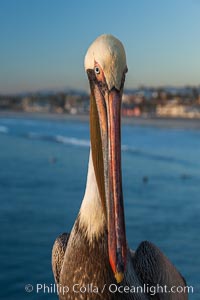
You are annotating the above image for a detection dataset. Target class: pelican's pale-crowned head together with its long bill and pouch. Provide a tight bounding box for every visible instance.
[85,34,127,282]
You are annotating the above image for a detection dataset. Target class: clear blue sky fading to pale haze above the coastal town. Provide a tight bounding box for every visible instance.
[0,0,200,93]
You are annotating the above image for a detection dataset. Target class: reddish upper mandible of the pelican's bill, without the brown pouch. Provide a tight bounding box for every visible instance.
[107,89,126,282]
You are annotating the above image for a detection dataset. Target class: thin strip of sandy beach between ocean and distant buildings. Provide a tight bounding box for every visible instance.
[0,111,200,129]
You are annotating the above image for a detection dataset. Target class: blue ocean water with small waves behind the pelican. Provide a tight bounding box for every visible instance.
[0,118,200,300]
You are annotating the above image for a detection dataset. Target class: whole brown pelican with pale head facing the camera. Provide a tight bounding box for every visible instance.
[52,35,187,300]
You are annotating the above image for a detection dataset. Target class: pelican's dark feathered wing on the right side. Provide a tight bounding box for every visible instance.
[131,241,188,300]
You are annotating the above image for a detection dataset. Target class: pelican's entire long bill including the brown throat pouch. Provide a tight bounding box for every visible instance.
[88,74,126,282]
